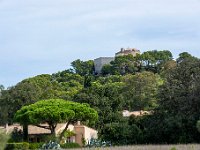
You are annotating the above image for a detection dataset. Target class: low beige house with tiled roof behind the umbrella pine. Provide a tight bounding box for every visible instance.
[0,122,98,146]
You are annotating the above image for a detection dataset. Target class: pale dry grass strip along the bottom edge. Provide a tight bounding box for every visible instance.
[68,144,200,150]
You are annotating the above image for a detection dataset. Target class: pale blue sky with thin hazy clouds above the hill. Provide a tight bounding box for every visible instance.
[0,0,200,87]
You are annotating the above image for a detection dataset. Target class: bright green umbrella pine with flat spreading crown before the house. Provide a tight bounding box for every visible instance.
[15,99,98,141]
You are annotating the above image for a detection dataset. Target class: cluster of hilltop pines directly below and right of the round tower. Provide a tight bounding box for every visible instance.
[102,50,173,75]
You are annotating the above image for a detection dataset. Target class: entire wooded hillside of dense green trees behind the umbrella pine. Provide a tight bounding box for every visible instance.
[0,50,200,145]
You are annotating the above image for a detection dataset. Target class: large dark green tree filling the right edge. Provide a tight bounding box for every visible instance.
[154,58,200,143]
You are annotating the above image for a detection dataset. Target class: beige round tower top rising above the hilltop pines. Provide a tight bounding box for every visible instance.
[115,48,140,57]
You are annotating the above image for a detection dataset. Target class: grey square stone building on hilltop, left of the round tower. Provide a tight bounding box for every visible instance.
[94,57,115,74]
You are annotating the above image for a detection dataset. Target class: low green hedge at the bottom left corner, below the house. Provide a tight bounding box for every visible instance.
[5,142,29,150]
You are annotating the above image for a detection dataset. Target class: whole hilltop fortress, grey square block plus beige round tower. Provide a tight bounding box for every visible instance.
[94,48,140,74]
